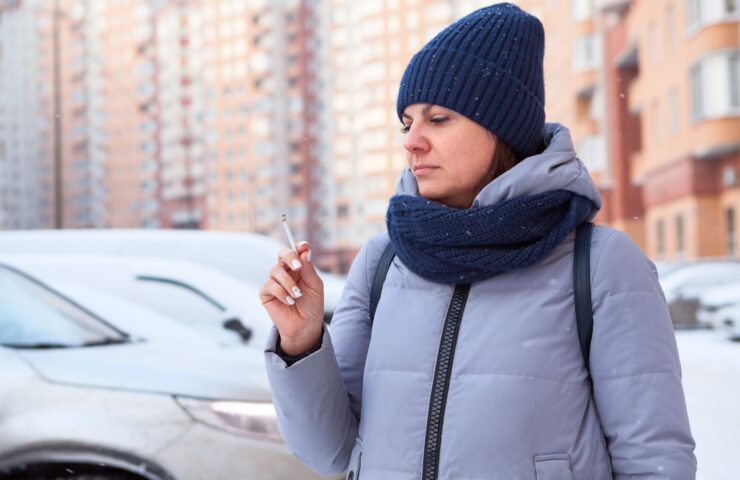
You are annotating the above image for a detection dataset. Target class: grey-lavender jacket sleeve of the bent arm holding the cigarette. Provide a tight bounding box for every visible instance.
[265,235,388,475]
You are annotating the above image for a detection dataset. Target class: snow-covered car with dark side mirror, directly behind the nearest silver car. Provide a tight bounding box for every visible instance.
[0,254,272,349]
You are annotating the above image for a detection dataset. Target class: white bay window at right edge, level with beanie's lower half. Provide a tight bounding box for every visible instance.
[690,50,740,120]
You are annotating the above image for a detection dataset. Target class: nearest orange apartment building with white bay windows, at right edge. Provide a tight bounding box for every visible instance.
[623,0,740,261]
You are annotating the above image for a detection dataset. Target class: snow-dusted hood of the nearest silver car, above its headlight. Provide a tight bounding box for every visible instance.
[18,341,271,402]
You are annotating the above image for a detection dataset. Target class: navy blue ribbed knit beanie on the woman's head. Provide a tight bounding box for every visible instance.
[396,3,545,159]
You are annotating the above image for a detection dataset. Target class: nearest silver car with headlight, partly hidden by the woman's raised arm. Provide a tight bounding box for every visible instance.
[0,263,330,480]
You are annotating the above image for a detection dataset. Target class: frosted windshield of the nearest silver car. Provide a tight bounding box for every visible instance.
[0,266,126,348]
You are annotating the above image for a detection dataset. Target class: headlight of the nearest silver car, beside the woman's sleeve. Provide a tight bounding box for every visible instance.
[175,397,282,442]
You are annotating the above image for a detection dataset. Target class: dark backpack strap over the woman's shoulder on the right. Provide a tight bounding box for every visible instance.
[573,222,594,370]
